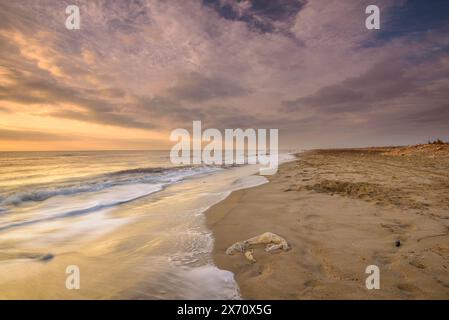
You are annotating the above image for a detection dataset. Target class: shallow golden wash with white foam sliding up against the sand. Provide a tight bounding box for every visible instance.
[0,160,266,300]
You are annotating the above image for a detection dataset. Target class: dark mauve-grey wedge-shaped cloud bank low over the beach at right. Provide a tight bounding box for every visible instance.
[280,59,449,121]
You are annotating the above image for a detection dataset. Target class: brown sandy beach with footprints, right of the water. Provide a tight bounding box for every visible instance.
[206,145,449,299]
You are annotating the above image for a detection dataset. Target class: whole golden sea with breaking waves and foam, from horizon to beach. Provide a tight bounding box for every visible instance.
[0,150,293,299]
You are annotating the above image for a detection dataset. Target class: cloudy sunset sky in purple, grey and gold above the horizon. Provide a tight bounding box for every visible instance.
[0,0,449,151]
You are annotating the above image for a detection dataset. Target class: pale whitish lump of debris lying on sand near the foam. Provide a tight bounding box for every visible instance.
[226,232,290,263]
